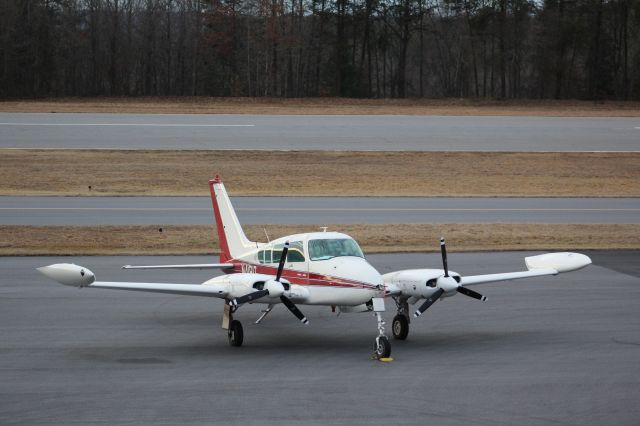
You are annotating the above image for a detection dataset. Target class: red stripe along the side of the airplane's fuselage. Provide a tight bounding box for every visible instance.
[228,259,376,289]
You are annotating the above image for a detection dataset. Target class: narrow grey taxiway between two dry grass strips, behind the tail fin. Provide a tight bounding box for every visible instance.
[0,197,640,225]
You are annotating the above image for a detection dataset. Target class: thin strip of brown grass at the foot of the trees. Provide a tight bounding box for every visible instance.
[0,97,640,117]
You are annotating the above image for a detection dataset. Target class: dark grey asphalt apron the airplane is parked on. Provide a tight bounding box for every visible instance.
[0,252,640,426]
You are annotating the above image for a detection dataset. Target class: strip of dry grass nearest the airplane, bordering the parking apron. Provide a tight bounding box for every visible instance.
[0,224,640,256]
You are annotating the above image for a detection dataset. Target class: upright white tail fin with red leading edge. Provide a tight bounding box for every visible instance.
[209,176,257,263]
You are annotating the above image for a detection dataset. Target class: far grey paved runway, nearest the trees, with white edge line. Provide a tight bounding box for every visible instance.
[0,113,640,151]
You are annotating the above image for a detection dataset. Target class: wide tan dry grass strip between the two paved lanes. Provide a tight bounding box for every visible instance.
[0,149,640,197]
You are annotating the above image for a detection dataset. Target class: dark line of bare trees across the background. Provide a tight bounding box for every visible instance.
[0,0,640,100]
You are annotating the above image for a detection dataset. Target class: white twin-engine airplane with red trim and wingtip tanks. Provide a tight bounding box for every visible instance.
[38,176,591,359]
